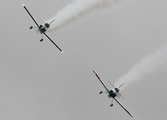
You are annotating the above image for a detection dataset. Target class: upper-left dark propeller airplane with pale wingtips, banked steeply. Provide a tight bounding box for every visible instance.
[23,4,63,53]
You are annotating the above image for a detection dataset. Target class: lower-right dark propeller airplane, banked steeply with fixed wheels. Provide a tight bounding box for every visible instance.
[93,70,133,117]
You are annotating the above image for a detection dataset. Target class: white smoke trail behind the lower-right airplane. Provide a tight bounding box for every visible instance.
[115,44,167,90]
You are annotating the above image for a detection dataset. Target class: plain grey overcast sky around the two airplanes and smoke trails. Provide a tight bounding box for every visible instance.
[0,0,167,120]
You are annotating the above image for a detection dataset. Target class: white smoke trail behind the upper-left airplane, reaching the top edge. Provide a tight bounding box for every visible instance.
[48,0,123,29]
